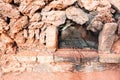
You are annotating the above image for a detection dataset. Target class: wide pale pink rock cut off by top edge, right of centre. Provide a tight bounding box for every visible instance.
[78,0,111,11]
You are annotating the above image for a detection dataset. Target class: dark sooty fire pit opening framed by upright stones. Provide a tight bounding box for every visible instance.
[58,20,98,50]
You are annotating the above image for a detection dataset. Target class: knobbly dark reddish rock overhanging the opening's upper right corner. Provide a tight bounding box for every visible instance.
[87,9,115,32]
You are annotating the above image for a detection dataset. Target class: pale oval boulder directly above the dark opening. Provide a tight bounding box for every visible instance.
[66,6,89,25]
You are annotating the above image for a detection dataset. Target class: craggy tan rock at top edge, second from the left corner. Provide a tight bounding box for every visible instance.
[19,0,45,17]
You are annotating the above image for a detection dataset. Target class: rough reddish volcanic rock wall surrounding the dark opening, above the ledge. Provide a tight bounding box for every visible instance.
[0,0,120,54]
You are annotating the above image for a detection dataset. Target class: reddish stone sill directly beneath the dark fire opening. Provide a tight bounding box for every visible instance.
[55,49,98,58]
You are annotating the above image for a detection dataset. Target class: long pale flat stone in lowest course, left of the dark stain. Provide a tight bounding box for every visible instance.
[33,63,73,72]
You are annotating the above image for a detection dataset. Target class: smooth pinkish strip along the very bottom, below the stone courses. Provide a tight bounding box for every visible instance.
[0,69,120,80]
